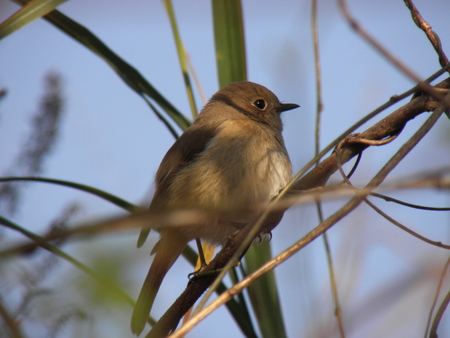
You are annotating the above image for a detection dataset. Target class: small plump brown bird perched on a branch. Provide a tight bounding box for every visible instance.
[131,81,299,335]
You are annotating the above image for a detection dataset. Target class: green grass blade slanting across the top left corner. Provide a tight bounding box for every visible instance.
[0,0,67,39]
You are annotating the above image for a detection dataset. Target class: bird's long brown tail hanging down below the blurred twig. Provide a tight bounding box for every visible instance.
[131,230,188,335]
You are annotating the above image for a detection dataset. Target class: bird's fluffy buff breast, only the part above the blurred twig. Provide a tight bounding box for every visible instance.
[167,120,292,209]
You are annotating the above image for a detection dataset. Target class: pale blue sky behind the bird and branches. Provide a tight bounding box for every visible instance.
[0,0,450,337]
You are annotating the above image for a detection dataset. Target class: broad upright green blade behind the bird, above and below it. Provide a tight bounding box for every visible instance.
[212,0,286,338]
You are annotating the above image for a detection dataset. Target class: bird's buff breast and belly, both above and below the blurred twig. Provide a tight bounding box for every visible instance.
[160,120,292,243]
